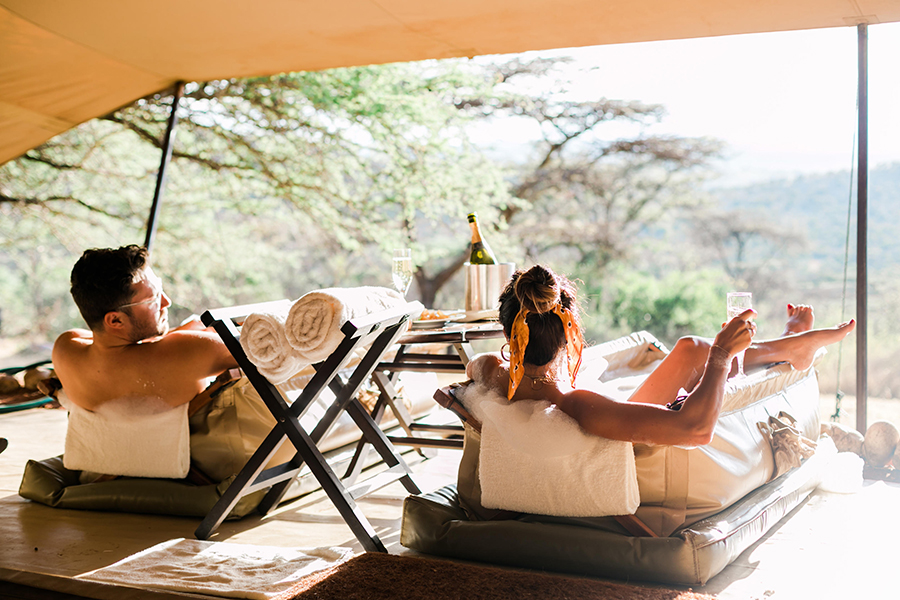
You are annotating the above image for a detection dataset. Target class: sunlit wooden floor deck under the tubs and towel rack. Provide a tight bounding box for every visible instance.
[0,409,900,600]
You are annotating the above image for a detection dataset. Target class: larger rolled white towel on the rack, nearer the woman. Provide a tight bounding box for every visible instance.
[284,287,406,363]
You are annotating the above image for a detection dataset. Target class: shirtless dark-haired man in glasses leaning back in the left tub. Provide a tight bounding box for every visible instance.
[53,245,237,410]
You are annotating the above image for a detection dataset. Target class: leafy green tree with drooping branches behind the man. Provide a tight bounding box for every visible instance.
[0,63,507,330]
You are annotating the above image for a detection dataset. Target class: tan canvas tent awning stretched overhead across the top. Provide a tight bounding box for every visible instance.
[0,0,900,164]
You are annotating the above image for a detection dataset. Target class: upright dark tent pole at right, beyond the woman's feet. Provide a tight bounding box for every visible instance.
[856,23,869,433]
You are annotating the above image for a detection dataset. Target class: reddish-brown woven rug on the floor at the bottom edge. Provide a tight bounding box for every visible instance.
[278,552,714,600]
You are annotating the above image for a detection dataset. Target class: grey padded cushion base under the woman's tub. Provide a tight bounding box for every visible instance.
[400,450,820,585]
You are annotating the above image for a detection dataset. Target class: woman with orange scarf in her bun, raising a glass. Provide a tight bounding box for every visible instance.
[467,265,856,446]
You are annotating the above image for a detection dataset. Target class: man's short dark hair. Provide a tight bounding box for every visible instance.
[71,244,149,330]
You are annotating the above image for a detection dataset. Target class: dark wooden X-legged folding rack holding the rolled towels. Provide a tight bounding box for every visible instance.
[195,300,420,552]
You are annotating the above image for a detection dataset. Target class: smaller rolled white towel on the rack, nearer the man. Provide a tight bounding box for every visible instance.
[241,306,310,384]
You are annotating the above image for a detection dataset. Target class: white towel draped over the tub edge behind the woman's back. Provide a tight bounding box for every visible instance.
[464,385,640,517]
